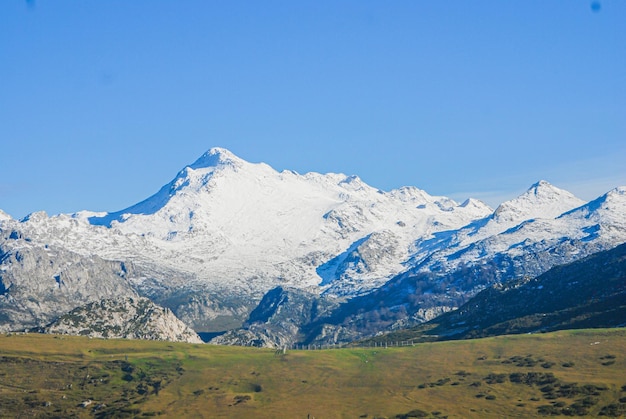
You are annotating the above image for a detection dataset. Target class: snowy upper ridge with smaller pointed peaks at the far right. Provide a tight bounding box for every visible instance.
[412,181,626,275]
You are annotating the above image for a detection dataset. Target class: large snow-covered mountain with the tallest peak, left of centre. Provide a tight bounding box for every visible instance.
[1,149,491,293]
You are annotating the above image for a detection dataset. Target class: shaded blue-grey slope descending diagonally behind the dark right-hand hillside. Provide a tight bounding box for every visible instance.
[214,182,626,344]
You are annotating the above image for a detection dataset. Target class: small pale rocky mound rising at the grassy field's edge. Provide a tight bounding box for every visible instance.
[42,297,202,343]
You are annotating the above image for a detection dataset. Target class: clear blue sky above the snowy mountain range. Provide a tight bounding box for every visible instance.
[0,0,626,218]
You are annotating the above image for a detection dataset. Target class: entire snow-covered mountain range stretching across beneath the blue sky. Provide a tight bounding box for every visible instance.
[0,148,626,344]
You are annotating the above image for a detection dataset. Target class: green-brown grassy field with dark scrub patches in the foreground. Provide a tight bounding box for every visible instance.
[0,329,626,419]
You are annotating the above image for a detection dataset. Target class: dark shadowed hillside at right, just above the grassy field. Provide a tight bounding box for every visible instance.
[360,244,626,340]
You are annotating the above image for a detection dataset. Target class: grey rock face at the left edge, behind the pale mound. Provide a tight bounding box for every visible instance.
[0,231,137,331]
